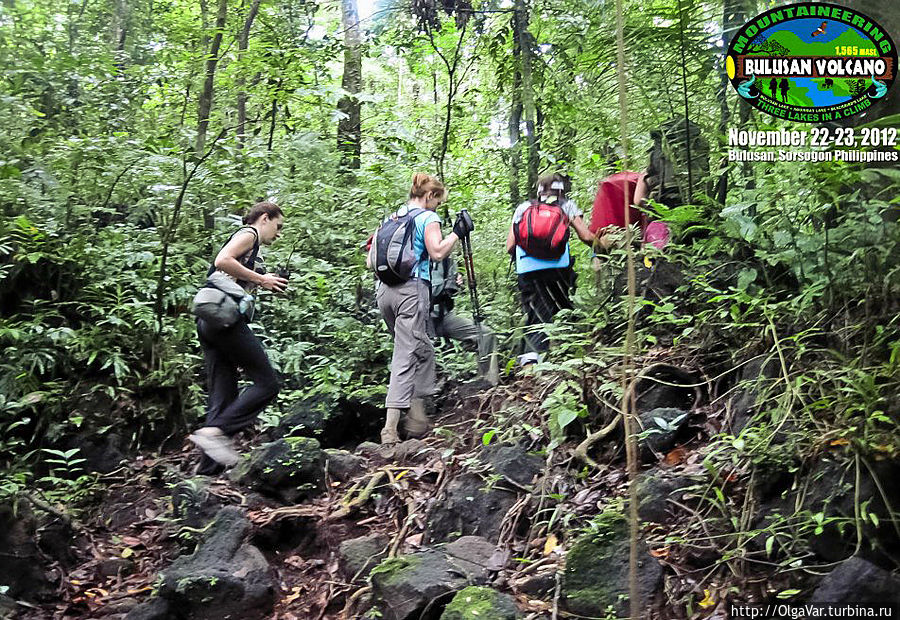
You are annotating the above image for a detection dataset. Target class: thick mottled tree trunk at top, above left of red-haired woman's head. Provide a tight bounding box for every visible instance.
[337,0,362,170]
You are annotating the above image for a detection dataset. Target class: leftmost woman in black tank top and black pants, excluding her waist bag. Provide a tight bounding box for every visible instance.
[190,202,287,475]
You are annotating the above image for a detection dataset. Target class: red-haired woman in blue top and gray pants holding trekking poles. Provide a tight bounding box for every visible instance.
[366,173,473,444]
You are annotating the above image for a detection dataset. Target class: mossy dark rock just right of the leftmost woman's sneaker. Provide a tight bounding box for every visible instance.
[231,437,325,504]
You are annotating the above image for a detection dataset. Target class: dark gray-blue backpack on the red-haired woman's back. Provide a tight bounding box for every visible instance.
[370,208,427,286]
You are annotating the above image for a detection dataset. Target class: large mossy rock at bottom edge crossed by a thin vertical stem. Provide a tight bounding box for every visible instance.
[562,512,662,616]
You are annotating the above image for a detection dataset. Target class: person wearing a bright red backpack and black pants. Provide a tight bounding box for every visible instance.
[506,173,594,366]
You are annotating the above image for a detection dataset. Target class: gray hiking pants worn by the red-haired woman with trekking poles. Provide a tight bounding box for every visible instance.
[375,278,435,409]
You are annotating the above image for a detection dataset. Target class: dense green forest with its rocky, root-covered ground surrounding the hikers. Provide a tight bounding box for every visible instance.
[0,0,900,620]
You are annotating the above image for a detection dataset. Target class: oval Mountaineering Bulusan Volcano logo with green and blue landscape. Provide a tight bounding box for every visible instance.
[725,2,897,123]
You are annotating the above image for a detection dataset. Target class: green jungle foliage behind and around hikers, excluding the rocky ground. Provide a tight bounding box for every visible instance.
[0,0,900,612]
